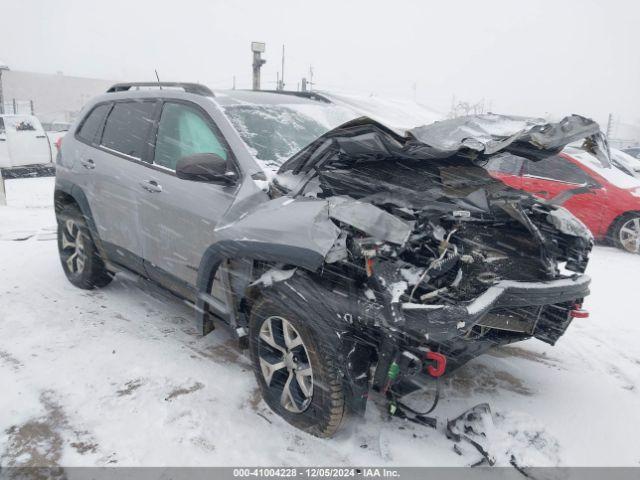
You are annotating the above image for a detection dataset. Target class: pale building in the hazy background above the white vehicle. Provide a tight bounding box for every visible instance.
[0,65,116,123]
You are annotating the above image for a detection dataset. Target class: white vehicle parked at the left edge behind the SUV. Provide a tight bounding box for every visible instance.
[0,115,53,170]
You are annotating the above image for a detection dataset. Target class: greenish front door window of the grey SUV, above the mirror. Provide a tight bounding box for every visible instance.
[153,103,228,170]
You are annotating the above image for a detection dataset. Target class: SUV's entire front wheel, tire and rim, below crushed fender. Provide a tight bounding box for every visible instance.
[249,295,345,437]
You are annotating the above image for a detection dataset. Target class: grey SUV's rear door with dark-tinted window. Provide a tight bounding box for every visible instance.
[81,99,158,272]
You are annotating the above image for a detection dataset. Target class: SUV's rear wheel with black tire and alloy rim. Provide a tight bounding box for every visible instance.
[56,204,113,290]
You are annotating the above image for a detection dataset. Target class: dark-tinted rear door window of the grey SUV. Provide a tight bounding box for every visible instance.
[100,102,156,159]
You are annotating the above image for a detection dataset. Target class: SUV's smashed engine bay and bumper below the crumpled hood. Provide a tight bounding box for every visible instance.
[320,165,593,398]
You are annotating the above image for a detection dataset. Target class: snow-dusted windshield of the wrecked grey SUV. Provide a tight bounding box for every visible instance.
[225,104,359,170]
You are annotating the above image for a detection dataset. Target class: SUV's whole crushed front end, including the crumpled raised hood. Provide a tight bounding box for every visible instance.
[275,116,603,398]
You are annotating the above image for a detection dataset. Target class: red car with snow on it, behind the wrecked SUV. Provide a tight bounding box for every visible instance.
[486,148,640,253]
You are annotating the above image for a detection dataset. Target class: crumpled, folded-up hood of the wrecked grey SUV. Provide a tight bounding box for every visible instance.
[278,113,610,174]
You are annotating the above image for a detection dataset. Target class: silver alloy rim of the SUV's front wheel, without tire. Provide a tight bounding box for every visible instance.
[258,316,313,413]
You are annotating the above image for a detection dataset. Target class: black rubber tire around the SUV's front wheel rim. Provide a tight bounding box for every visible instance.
[249,285,347,437]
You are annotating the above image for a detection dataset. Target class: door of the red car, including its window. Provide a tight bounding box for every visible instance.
[522,155,607,235]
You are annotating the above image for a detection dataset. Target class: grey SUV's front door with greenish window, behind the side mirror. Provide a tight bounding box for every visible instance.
[140,100,238,296]
